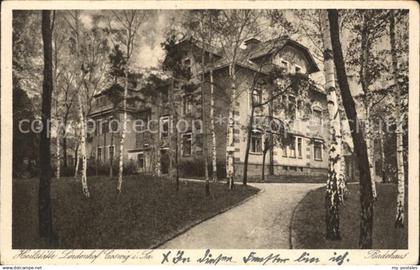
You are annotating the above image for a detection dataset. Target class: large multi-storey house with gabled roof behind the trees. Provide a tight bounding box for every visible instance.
[88,37,329,177]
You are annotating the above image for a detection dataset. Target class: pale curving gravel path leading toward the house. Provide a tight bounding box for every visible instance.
[158,183,322,249]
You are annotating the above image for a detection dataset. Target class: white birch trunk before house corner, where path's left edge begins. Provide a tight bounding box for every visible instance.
[226,63,236,190]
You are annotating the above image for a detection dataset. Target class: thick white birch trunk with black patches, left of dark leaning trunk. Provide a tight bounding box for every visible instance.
[322,12,344,240]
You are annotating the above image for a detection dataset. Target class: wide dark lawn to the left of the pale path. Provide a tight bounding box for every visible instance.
[12,176,258,249]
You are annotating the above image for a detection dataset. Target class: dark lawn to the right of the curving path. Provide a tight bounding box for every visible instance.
[292,184,408,249]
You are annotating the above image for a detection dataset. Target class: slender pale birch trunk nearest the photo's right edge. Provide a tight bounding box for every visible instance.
[389,11,405,228]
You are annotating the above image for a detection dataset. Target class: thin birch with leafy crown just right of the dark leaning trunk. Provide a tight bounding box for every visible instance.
[343,10,388,199]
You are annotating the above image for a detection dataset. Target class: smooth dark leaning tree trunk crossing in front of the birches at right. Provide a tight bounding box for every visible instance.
[328,9,373,249]
